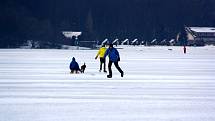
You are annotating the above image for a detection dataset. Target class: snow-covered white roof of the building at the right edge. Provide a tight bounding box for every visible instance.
[189,27,215,33]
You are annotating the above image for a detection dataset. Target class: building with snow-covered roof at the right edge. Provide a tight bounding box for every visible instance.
[185,27,215,46]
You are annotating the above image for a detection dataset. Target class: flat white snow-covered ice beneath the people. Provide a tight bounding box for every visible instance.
[0,46,215,121]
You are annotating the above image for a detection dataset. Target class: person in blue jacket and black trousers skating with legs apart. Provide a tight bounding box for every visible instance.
[104,44,124,78]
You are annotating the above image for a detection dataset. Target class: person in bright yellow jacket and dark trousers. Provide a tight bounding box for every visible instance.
[95,45,107,73]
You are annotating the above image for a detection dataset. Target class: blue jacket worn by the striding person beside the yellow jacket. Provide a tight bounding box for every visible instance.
[104,48,120,62]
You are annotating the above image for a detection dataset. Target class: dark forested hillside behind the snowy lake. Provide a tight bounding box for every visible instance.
[0,0,215,48]
